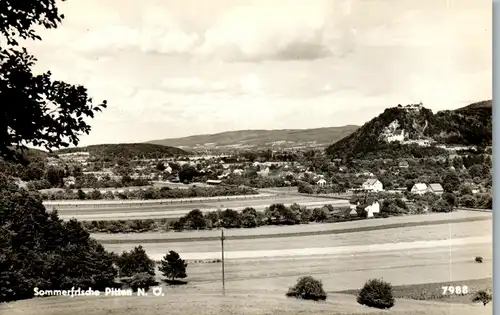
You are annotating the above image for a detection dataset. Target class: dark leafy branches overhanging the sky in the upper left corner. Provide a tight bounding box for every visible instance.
[0,0,106,159]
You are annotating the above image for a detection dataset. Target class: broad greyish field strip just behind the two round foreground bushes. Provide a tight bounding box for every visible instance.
[184,244,492,292]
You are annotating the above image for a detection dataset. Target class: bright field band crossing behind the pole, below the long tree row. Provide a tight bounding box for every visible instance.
[104,220,492,259]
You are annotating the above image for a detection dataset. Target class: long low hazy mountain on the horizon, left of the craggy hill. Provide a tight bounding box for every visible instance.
[147,125,359,150]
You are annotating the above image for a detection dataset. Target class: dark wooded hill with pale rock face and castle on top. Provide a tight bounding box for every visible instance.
[326,100,493,159]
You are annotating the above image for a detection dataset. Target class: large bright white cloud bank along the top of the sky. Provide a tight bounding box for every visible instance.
[34,0,344,61]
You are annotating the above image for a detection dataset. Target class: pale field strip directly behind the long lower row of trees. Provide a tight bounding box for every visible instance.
[55,197,349,221]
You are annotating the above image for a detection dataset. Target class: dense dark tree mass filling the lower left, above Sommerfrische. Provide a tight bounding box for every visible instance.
[0,176,116,302]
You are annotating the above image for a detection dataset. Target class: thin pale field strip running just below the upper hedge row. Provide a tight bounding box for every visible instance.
[43,193,276,208]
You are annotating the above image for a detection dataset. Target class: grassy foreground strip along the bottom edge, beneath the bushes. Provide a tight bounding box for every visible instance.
[0,289,492,315]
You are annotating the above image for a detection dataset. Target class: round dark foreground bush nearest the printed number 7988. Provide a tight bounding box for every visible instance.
[357,279,394,309]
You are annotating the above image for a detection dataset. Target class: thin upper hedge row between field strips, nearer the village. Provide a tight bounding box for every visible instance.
[42,186,258,200]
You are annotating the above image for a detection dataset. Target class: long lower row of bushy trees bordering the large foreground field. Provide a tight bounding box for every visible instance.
[83,195,440,233]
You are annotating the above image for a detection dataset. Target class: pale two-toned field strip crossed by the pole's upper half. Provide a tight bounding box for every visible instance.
[103,221,492,260]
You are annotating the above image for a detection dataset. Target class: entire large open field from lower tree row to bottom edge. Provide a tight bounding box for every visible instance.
[0,214,492,315]
